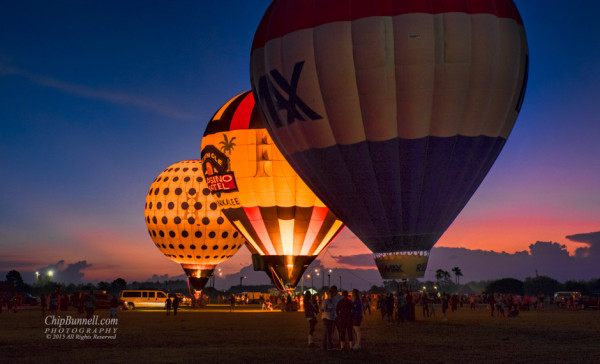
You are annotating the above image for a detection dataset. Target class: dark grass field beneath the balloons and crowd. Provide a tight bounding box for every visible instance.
[0,306,600,364]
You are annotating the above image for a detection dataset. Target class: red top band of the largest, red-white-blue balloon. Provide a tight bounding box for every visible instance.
[252,0,523,50]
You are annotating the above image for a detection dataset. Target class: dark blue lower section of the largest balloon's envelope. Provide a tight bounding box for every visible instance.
[288,135,506,253]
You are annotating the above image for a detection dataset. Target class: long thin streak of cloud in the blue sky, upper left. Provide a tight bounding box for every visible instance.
[0,62,198,121]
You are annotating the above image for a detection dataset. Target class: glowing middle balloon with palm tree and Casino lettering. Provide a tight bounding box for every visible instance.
[201,91,343,290]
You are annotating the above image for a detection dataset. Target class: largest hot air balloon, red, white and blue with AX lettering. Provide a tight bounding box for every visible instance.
[250,0,528,279]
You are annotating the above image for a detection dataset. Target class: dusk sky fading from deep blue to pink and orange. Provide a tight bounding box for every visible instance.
[0,0,600,288]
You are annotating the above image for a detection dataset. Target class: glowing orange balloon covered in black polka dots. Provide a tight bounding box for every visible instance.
[145,160,244,291]
